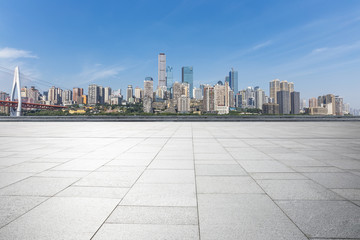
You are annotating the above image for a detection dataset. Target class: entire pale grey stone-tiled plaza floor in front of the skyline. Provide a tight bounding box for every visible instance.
[0,122,360,240]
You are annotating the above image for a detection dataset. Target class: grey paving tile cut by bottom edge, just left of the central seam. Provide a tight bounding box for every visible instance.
[93,224,199,240]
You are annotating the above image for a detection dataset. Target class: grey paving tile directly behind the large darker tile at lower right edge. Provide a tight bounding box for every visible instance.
[257,180,343,200]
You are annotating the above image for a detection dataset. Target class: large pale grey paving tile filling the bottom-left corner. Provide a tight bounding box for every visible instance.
[0,197,118,240]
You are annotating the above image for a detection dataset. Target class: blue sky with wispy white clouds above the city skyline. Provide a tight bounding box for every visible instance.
[0,0,360,108]
